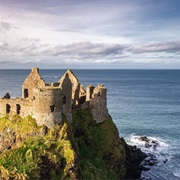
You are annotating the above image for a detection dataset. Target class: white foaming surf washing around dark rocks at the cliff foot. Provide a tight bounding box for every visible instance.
[126,134,180,180]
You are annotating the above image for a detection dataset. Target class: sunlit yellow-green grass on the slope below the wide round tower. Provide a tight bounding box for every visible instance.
[0,117,76,179]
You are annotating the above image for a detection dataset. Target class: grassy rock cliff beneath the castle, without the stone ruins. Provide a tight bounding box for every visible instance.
[0,109,144,180]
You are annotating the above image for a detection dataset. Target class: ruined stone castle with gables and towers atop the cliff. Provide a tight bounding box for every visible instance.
[0,68,109,127]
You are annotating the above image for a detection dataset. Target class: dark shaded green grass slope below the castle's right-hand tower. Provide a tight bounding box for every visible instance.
[72,110,126,179]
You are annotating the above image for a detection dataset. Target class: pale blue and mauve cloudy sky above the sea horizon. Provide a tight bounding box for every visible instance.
[0,0,180,69]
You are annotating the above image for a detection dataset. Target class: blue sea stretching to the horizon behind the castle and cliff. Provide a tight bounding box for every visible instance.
[0,69,180,180]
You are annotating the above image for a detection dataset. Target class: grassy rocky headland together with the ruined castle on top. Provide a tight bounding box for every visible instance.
[0,68,146,180]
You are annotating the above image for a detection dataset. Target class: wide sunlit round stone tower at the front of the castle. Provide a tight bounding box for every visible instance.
[33,87,63,127]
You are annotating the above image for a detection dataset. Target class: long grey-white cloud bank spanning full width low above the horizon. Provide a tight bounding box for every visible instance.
[0,38,180,67]
